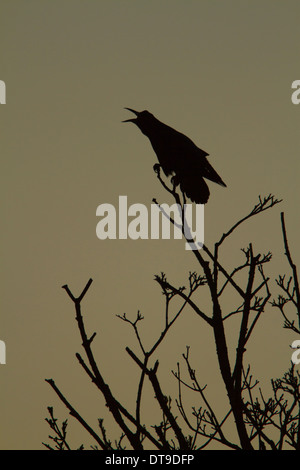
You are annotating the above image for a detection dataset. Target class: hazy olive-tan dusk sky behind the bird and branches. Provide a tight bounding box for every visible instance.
[0,0,300,449]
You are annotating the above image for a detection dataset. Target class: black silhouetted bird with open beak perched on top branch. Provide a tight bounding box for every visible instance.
[123,108,226,204]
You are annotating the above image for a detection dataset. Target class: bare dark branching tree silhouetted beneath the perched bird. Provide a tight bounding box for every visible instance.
[45,171,300,450]
